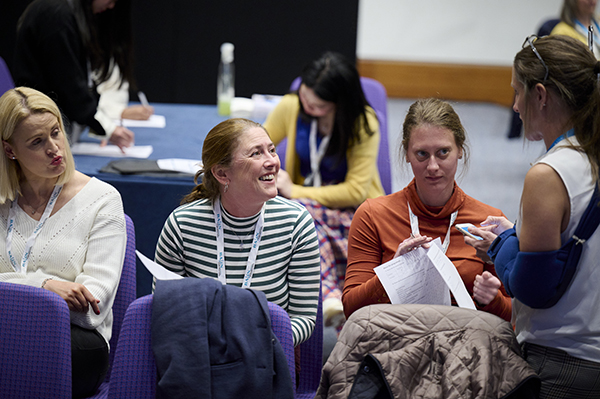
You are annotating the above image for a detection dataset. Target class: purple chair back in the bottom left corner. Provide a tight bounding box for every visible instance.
[0,283,71,399]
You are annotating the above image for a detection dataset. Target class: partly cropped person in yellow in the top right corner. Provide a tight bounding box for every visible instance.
[550,0,600,58]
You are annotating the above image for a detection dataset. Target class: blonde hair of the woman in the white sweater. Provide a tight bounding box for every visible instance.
[0,87,75,204]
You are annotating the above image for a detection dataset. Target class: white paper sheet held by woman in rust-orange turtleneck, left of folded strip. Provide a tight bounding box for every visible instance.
[375,239,450,306]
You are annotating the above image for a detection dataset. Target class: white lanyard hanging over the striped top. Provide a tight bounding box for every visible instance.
[213,198,265,288]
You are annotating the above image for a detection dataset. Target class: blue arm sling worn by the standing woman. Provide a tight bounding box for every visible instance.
[488,186,600,309]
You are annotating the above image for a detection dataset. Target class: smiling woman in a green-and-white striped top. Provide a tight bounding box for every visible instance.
[155,119,320,346]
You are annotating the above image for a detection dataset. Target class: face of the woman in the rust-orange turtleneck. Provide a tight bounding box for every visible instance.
[406,123,463,206]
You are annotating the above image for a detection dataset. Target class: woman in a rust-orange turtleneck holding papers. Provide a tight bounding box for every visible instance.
[342,99,511,321]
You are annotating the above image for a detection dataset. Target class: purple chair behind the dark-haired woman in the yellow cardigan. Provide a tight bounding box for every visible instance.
[277,77,392,194]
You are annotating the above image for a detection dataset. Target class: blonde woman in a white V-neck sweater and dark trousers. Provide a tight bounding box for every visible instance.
[0,87,127,398]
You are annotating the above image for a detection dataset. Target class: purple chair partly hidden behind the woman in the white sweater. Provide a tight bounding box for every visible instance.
[92,215,136,398]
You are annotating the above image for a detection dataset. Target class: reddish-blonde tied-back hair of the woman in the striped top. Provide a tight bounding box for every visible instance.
[181,118,268,204]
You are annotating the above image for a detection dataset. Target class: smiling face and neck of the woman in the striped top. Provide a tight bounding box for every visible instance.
[213,127,280,217]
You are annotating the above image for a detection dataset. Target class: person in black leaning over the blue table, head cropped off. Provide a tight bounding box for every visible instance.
[13,0,153,148]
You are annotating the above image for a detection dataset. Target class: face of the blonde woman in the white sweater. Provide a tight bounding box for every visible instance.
[3,112,66,179]
